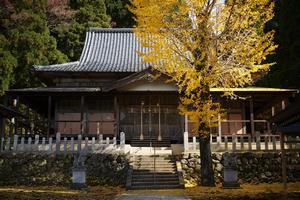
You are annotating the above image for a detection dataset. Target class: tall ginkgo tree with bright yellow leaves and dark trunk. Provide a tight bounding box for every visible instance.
[129,0,276,186]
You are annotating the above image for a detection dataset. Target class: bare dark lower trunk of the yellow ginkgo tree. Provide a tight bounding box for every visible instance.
[199,135,215,187]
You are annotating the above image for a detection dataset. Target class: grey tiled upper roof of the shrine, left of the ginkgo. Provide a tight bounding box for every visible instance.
[34,28,149,72]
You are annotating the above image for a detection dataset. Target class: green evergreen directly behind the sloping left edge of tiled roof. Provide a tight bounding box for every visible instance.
[52,0,110,61]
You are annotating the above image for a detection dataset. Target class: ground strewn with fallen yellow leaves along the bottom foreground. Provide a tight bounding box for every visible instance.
[0,182,300,200]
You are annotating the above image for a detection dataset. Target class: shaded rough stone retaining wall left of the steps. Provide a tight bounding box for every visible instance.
[0,154,129,186]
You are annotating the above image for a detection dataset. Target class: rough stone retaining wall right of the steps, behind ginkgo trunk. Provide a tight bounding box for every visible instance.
[181,152,300,186]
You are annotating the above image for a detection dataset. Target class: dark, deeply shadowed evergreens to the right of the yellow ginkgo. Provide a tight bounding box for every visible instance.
[257,0,300,88]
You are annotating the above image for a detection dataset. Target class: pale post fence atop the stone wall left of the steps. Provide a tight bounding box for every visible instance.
[0,132,125,154]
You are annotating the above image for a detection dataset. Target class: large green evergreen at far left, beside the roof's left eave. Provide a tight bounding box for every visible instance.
[0,0,67,91]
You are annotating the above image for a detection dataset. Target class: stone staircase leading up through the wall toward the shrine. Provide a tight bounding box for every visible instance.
[126,155,184,189]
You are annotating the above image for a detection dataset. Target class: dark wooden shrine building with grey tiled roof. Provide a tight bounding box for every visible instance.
[7,28,297,146]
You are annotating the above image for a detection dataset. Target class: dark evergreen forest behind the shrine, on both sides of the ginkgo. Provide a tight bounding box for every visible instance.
[0,0,300,95]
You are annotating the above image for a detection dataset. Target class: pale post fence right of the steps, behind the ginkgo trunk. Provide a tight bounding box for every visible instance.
[184,132,299,152]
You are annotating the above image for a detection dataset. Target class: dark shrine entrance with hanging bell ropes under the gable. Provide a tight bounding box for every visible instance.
[120,95,183,147]
